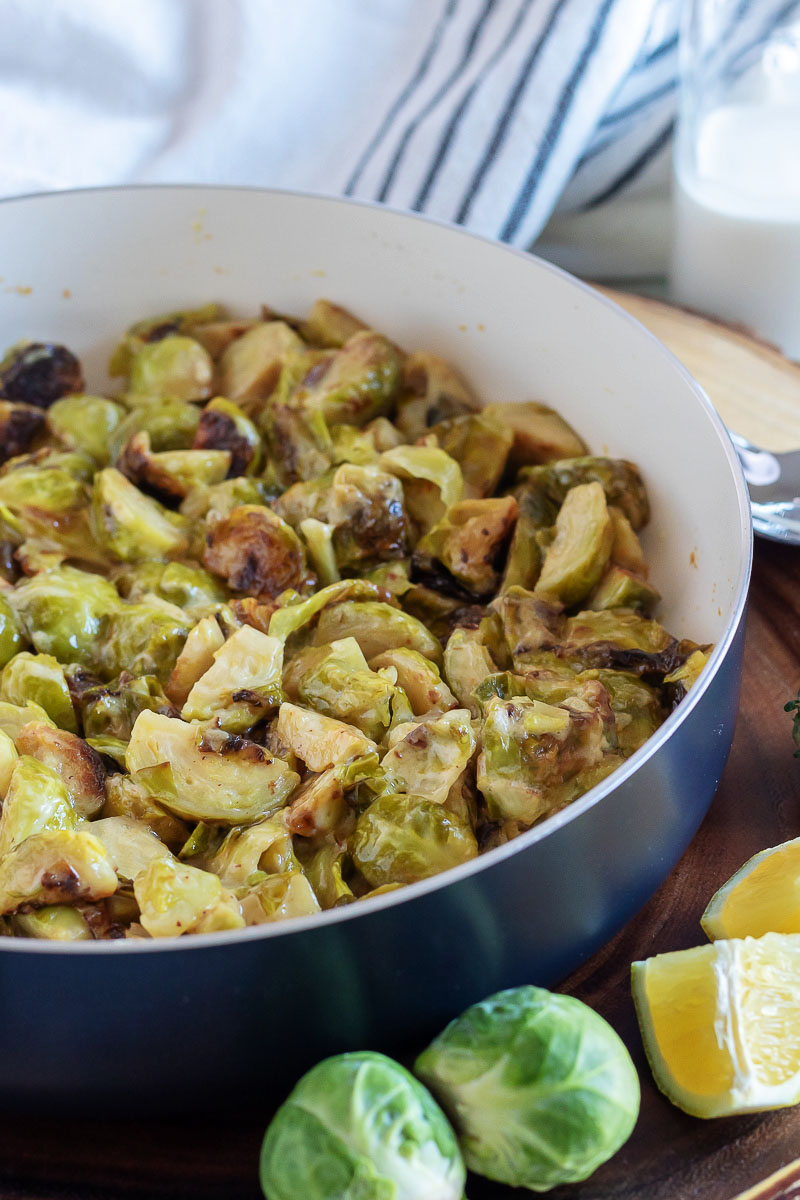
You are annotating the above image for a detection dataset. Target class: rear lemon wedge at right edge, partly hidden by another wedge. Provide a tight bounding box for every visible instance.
[700,838,800,941]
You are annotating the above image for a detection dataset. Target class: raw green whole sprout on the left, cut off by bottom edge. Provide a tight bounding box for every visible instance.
[260,1050,467,1200]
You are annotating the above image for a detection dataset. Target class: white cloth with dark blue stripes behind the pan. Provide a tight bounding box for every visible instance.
[0,0,795,270]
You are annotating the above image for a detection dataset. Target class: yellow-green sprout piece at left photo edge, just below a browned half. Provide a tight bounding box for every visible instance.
[0,754,78,858]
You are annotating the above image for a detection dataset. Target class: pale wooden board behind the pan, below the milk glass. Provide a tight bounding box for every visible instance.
[597,287,800,450]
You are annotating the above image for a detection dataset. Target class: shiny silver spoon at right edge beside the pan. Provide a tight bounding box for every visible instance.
[730,433,800,545]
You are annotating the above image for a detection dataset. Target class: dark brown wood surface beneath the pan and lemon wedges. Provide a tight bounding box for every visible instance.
[0,541,800,1200]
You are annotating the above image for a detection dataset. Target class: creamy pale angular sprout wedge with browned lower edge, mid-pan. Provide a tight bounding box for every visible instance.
[181,625,283,733]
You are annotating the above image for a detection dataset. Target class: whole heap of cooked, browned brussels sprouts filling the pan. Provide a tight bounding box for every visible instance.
[0,300,710,942]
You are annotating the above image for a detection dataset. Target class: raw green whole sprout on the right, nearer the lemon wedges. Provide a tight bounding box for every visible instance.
[414,986,639,1192]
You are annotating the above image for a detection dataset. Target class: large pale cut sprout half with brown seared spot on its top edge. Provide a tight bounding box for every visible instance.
[126,710,300,824]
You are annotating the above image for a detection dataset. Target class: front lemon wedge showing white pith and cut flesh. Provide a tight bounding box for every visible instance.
[632,934,800,1117]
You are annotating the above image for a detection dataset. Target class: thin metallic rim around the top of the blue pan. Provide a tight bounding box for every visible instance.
[0,182,753,956]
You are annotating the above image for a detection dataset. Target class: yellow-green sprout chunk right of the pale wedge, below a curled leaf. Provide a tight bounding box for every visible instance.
[293,637,411,742]
